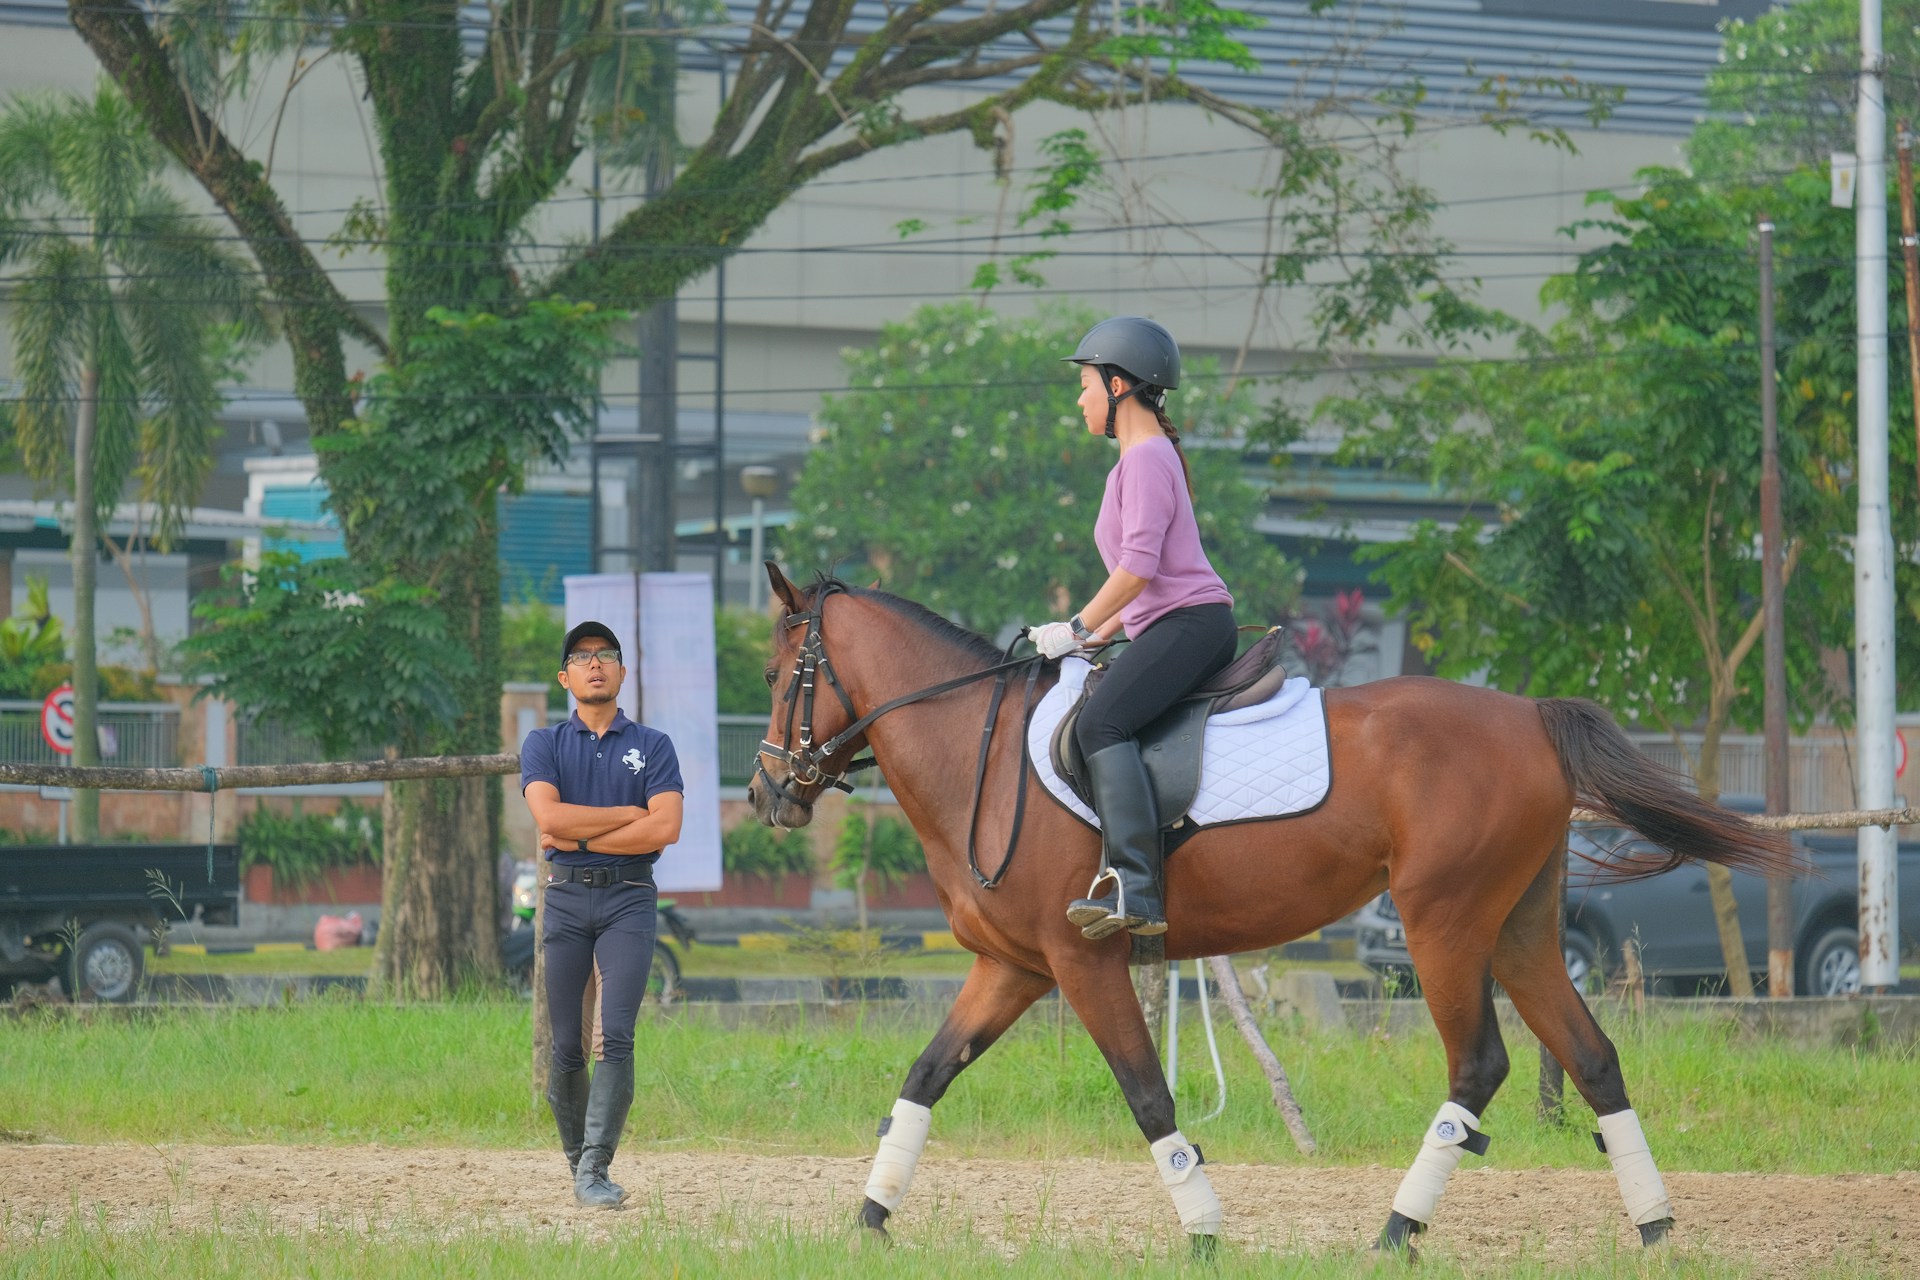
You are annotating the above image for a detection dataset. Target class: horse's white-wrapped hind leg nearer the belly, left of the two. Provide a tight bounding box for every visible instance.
[1375,924,1507,1251]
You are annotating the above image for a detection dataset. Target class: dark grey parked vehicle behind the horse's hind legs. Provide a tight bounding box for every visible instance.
[1354,798,1920,996]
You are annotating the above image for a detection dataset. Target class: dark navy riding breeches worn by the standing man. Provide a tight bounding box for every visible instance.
[540,882,659,1071]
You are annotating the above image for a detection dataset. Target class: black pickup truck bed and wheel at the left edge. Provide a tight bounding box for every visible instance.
[0,844,240,1002]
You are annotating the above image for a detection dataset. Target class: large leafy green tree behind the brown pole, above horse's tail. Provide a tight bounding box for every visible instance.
[1336,169,1920,990]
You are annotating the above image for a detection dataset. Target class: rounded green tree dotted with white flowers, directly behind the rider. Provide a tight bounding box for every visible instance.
[787,303,1300,637]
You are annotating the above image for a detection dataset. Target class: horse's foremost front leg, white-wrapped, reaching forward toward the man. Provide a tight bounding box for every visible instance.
[860,956,1054,1238]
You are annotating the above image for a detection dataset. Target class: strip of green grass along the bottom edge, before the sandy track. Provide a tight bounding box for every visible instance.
[0,1209,1880,1280]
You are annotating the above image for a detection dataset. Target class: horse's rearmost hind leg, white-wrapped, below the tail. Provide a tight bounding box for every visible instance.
[1494,858,1674,1245]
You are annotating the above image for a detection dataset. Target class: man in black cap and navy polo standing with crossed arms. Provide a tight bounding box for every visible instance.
[520,622,684,1209]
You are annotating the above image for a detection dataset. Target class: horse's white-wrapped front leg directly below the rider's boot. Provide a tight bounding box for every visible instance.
[1050,951,1221,1257]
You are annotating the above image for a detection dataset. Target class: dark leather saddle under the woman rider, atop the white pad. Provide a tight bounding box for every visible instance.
[1050,628,1286,832]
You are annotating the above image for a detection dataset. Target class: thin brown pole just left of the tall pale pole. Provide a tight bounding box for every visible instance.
[1761,213,1793,1000]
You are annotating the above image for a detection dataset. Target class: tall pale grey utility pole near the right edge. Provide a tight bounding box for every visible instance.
[1853,0,1901,990]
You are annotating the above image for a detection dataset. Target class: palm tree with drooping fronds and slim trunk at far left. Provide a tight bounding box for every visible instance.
[0,81,265,839]
